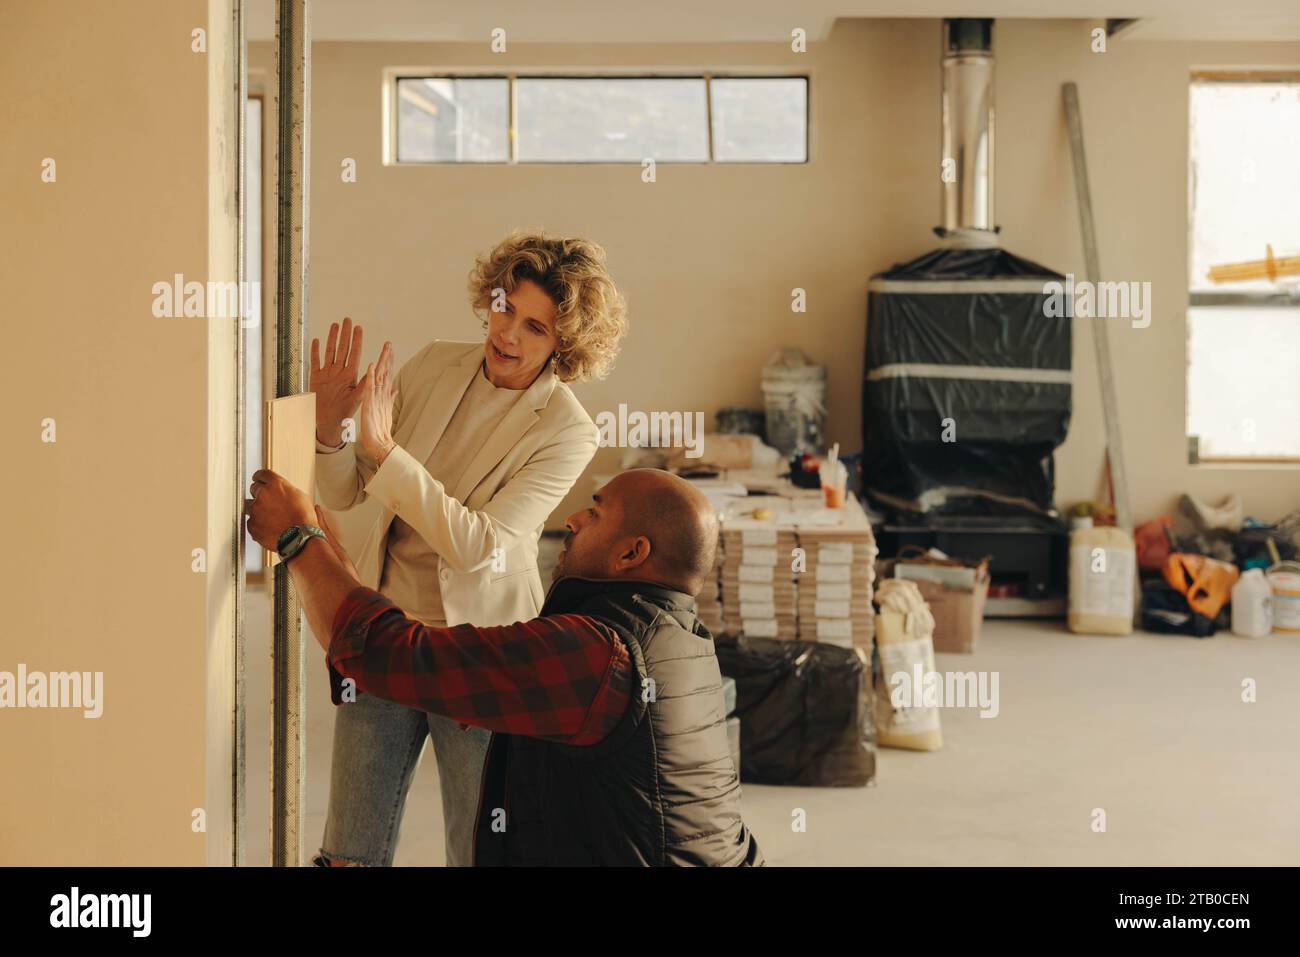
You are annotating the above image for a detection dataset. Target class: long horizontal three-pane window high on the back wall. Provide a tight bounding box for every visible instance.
[387,74,809,164]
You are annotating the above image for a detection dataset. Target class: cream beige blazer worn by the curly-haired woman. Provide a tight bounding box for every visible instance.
[316,339,599,625]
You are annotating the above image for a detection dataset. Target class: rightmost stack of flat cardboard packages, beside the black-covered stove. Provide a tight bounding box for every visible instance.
[796,497,876,649]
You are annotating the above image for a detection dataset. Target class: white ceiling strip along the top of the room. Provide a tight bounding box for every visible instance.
[247,0,1300,43]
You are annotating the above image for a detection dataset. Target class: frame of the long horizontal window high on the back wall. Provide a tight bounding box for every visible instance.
[384,66,813,166]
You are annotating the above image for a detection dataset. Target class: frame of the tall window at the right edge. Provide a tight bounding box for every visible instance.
[1183,69,1300,467]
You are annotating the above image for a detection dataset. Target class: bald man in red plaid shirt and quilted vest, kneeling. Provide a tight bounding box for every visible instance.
[246,468,763,866]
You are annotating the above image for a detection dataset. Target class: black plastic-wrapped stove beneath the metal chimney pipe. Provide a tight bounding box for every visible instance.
[862,248,1073,515]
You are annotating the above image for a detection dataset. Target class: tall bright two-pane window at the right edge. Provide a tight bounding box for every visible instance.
[1187,74,1300,462]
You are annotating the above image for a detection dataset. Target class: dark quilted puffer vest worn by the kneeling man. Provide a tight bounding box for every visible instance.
[475,577,763,867]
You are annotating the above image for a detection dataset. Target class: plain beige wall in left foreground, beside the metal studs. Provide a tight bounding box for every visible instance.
[0,0,234,865]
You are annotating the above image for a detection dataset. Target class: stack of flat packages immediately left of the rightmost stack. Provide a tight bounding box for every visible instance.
[722,518,798,641]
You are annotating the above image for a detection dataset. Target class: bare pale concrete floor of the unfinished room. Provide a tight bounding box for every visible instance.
[247,592,1300,866]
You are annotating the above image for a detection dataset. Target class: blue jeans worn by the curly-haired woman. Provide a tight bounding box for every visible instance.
[321,694,491,867]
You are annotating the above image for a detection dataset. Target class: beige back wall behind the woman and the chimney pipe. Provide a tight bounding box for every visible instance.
[254,20,1300,546]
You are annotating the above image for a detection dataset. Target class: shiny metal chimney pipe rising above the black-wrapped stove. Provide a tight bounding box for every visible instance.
[936,18,997,246]
